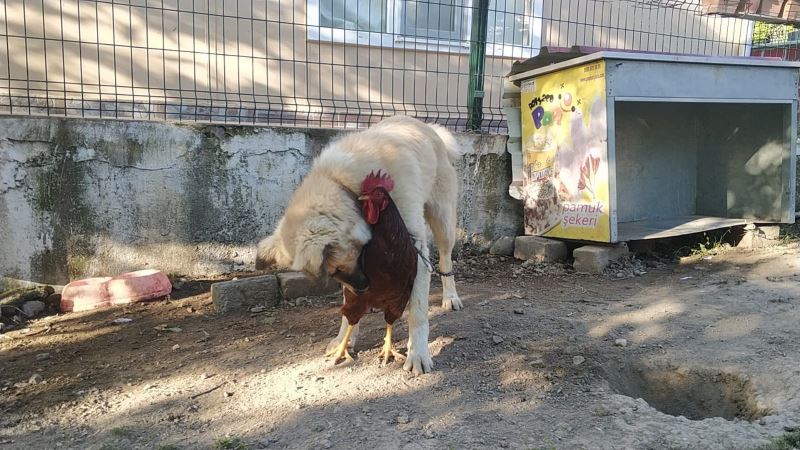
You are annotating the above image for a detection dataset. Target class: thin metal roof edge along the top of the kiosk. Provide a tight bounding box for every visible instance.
[508,51,800,81]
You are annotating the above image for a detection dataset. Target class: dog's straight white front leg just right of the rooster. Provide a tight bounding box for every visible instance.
[403,251,433,375]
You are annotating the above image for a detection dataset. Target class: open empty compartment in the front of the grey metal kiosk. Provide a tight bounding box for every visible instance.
[614,101,791,241]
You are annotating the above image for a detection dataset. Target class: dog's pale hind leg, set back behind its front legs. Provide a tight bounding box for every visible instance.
[425,199,463,311]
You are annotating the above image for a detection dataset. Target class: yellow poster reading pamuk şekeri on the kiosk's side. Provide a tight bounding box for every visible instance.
[521,61,611,242]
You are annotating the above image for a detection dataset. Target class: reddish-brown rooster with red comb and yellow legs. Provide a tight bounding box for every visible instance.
[326,170,417,366]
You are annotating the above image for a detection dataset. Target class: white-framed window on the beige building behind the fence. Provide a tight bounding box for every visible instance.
[308,0,542,58]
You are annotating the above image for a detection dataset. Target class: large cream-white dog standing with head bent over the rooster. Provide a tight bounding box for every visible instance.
[256,116,462,375]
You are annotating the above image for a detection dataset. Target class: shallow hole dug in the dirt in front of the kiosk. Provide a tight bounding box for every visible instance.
[605,365,771,421]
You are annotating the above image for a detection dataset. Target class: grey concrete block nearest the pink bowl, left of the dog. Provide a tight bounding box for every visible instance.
[211,275,281,313]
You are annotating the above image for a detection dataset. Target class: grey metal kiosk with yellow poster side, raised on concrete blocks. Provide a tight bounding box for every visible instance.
[504,51,800,243]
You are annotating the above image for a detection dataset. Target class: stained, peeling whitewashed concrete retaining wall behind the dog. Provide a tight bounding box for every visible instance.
[0,117,522,283]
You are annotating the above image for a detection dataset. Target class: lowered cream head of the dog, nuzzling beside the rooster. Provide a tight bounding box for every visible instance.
[256,179,371,293]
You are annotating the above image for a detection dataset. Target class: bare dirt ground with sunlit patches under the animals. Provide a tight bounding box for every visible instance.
[0,245,800,449]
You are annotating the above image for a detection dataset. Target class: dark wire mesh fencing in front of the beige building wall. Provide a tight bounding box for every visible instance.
[0,0,754,131]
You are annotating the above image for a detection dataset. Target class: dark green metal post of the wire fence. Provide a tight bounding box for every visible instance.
[467,0,489,130]
